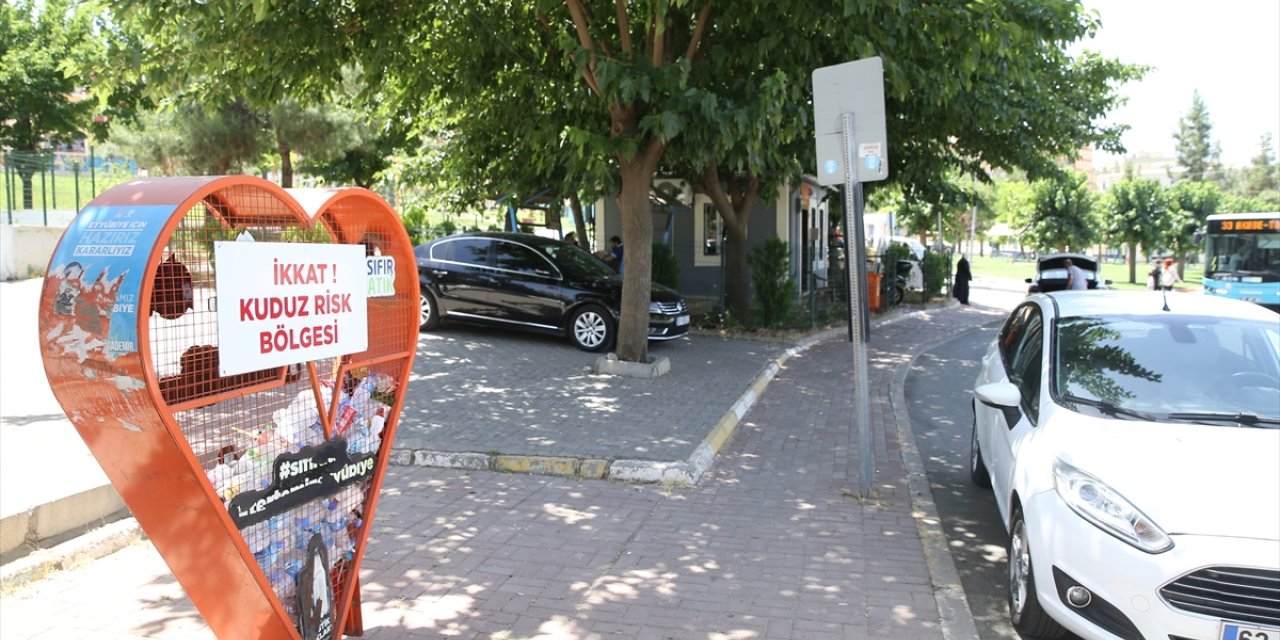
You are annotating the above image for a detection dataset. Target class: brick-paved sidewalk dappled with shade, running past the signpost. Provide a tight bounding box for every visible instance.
[0,302,1002,639]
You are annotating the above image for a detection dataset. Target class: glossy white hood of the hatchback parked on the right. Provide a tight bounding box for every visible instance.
[1043,417,1280,540]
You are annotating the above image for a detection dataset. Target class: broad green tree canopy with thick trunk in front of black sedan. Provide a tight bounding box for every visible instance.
[97,0,1142,360]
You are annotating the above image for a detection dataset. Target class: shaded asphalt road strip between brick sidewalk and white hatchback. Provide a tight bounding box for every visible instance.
[904,323,1090,640]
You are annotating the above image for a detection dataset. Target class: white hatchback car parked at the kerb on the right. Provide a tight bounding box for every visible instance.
[969,291,1280,640]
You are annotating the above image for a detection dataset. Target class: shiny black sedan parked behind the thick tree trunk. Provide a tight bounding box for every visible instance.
[413,233,689,351]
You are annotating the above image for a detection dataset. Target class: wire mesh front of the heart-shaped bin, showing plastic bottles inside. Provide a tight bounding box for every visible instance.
[148,187,416,620]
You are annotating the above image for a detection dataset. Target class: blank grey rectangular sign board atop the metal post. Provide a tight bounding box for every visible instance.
[813,58,888,186]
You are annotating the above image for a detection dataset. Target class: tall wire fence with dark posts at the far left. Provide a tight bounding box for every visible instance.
[0,147,138,227]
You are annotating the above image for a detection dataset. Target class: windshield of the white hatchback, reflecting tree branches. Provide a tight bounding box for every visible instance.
[1051,314,1280,426]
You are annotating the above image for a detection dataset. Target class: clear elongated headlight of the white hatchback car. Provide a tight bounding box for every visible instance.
[1053,460,1174,553]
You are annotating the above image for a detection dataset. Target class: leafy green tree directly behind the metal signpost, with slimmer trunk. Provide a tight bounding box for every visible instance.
[666,1,1143,320]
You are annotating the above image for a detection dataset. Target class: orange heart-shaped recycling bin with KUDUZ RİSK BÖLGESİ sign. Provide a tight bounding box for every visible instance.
[40,177,419,639]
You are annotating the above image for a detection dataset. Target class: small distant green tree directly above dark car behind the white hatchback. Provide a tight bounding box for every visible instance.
[1023,172,1098,251]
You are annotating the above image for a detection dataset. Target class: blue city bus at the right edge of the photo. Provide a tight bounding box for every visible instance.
[1204,212,1280,314]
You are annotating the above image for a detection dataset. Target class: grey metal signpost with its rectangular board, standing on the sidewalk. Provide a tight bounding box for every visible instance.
[813,58,888,498]
